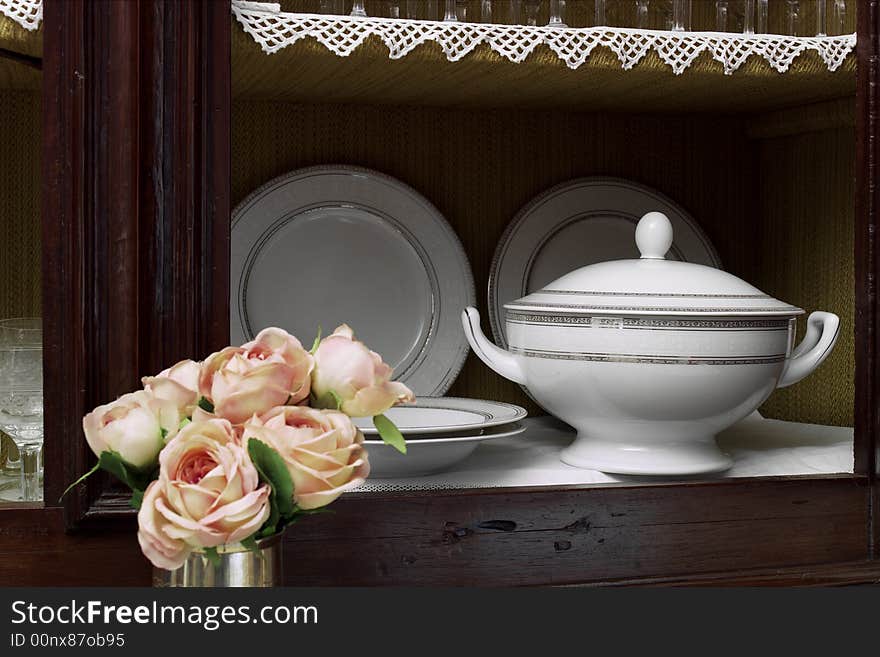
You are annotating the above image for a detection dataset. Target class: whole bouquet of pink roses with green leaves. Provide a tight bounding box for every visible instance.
[68,325,414,570]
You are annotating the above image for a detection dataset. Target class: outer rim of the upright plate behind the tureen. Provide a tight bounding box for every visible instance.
[486,176,723,348]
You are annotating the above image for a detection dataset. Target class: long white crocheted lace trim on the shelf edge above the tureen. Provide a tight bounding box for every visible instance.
[232,0,856,75]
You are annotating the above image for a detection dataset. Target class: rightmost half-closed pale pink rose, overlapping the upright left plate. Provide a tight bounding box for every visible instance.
[312,324,415,417]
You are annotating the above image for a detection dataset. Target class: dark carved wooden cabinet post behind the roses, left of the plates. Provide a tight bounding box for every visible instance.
[43,0,230,526]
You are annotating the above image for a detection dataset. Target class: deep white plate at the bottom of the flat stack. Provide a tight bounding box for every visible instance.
[364,422,526,478]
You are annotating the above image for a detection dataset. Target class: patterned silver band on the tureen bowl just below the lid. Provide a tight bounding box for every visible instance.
[507,311,789,331]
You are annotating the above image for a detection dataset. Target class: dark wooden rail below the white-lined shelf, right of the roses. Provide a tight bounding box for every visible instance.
[285,478,870,586]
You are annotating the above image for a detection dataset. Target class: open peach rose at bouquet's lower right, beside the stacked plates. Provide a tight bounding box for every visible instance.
[243,406,370,509]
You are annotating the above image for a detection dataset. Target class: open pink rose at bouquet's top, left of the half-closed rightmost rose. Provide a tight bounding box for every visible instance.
[199,328,314,424]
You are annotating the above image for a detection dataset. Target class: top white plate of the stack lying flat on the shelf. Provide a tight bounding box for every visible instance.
[354,397,528,439]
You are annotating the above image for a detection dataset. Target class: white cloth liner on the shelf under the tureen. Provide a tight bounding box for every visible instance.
[356,413,853,492]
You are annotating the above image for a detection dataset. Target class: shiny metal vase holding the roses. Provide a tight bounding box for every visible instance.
[153,534,284,587]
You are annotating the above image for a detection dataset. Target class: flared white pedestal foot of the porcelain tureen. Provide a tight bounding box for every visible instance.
[560,432,733,475]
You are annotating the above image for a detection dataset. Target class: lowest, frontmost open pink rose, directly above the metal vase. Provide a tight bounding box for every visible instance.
[138,419,270,570]
